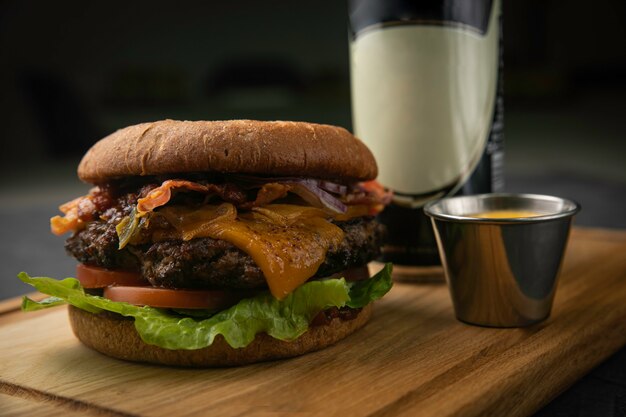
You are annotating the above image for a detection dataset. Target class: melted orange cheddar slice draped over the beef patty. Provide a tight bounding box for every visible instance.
[159,203,343,299]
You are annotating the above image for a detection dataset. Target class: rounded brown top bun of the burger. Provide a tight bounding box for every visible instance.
[78,120,377,183]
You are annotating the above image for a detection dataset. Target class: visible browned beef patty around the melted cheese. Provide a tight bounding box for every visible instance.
[65,218,384,289]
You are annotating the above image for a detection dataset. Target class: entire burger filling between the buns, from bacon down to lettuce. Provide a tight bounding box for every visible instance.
[19,175,391,349]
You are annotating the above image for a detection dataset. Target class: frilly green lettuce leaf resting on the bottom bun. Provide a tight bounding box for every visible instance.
[18,265,392,349]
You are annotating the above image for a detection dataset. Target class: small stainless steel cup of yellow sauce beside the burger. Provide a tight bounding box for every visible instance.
[424,194,580,327]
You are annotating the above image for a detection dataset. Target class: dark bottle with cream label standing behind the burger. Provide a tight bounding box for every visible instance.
[348,0,503,266]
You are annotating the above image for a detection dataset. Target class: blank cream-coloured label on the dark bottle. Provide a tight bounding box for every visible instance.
[351,2,499,206]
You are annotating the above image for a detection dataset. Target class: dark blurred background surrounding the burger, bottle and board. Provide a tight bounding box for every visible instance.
[0,0,626,416]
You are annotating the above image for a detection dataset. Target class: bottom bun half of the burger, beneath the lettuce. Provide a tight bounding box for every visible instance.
[69,304,372,367]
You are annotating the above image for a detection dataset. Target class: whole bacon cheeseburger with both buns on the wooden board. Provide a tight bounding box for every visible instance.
[19,120,391,367]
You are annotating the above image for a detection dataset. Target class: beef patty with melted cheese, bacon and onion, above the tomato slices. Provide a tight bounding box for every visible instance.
[52,177,387,298]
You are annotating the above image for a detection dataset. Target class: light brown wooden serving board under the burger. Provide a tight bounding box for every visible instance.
[0,229,626,417]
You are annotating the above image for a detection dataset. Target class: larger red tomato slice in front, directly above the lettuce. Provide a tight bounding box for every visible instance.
[104,286,250,309]
